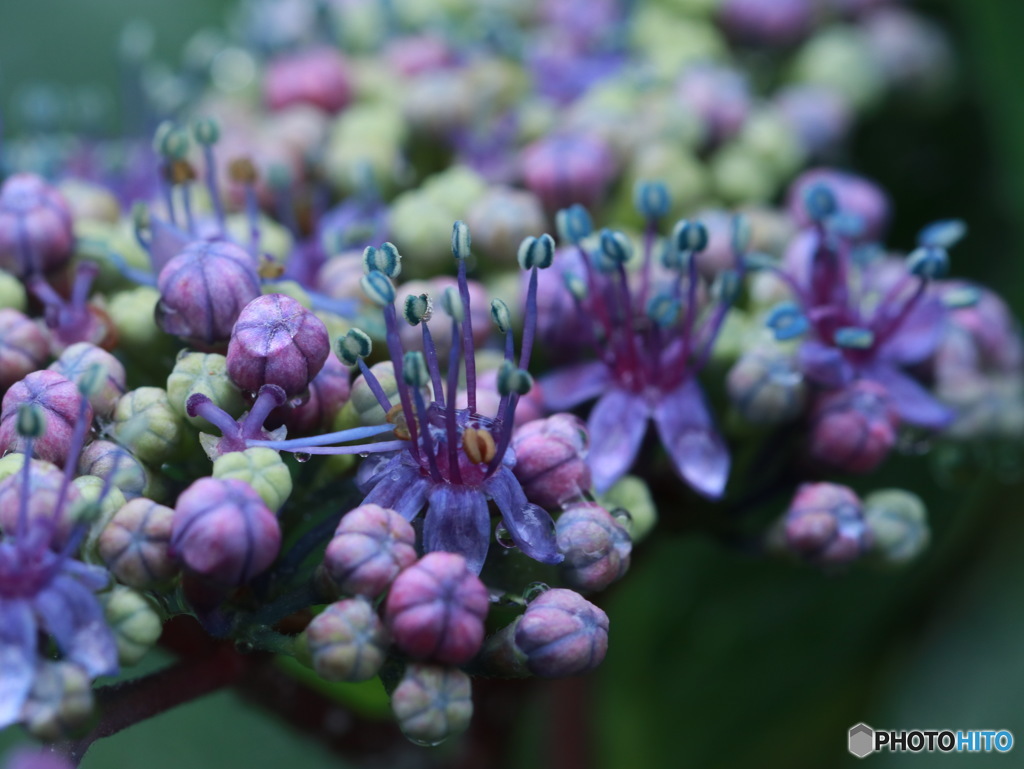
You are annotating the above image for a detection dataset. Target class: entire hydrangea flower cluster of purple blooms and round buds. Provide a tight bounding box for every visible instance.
[0,0,1011,767]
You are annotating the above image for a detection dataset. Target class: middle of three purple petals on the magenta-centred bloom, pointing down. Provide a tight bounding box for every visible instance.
[587,389,650,493]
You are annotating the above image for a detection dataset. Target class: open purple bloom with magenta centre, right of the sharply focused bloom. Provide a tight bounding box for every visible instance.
[541,201,738,499]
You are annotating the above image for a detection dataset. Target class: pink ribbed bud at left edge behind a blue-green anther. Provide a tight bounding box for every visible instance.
[0,371,92,465]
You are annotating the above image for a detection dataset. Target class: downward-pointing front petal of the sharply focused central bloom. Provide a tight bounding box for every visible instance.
[423,484,490,574]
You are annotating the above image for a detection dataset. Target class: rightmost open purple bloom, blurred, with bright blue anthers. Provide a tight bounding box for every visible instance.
[768,184,963,429]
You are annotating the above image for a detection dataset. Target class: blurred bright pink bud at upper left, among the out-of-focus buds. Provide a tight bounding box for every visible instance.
[263,46,353,113]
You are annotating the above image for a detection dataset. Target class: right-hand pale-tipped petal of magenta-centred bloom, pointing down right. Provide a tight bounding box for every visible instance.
[654,378,731,500]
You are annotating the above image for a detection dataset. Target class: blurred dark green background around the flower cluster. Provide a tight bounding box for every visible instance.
[0,0,1024,769]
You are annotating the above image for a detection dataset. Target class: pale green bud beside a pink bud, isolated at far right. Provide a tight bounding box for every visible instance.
[864,488,932,566]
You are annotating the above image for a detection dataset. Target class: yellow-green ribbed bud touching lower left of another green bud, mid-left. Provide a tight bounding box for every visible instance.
[114,387,181,466]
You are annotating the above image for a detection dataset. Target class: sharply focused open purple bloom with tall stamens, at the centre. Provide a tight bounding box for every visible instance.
[259,222,562,573]
